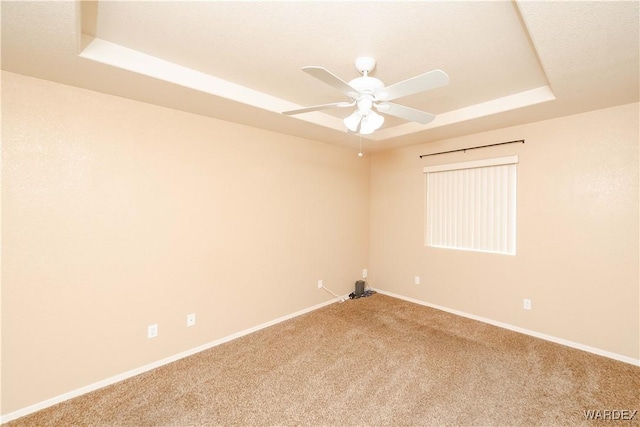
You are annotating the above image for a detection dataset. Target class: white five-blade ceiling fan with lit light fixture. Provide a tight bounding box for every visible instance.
[282,57,449,135]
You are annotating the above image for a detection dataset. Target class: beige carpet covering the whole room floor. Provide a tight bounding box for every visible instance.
[9,294,640,426]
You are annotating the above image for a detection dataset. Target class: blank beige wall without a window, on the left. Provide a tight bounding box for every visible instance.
[2,72,369,414]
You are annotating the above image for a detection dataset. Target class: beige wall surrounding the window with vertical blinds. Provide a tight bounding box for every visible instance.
[369,104,640,360]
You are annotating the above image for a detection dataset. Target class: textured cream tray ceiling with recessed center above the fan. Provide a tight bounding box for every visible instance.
[2,1,640,150]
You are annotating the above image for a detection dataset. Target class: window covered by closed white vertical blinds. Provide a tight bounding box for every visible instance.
[424,156,518,255]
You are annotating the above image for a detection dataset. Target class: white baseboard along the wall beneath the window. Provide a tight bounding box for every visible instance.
[375,289,640,366]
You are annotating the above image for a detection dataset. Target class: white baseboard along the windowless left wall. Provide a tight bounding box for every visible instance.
[0,297,348,424]
